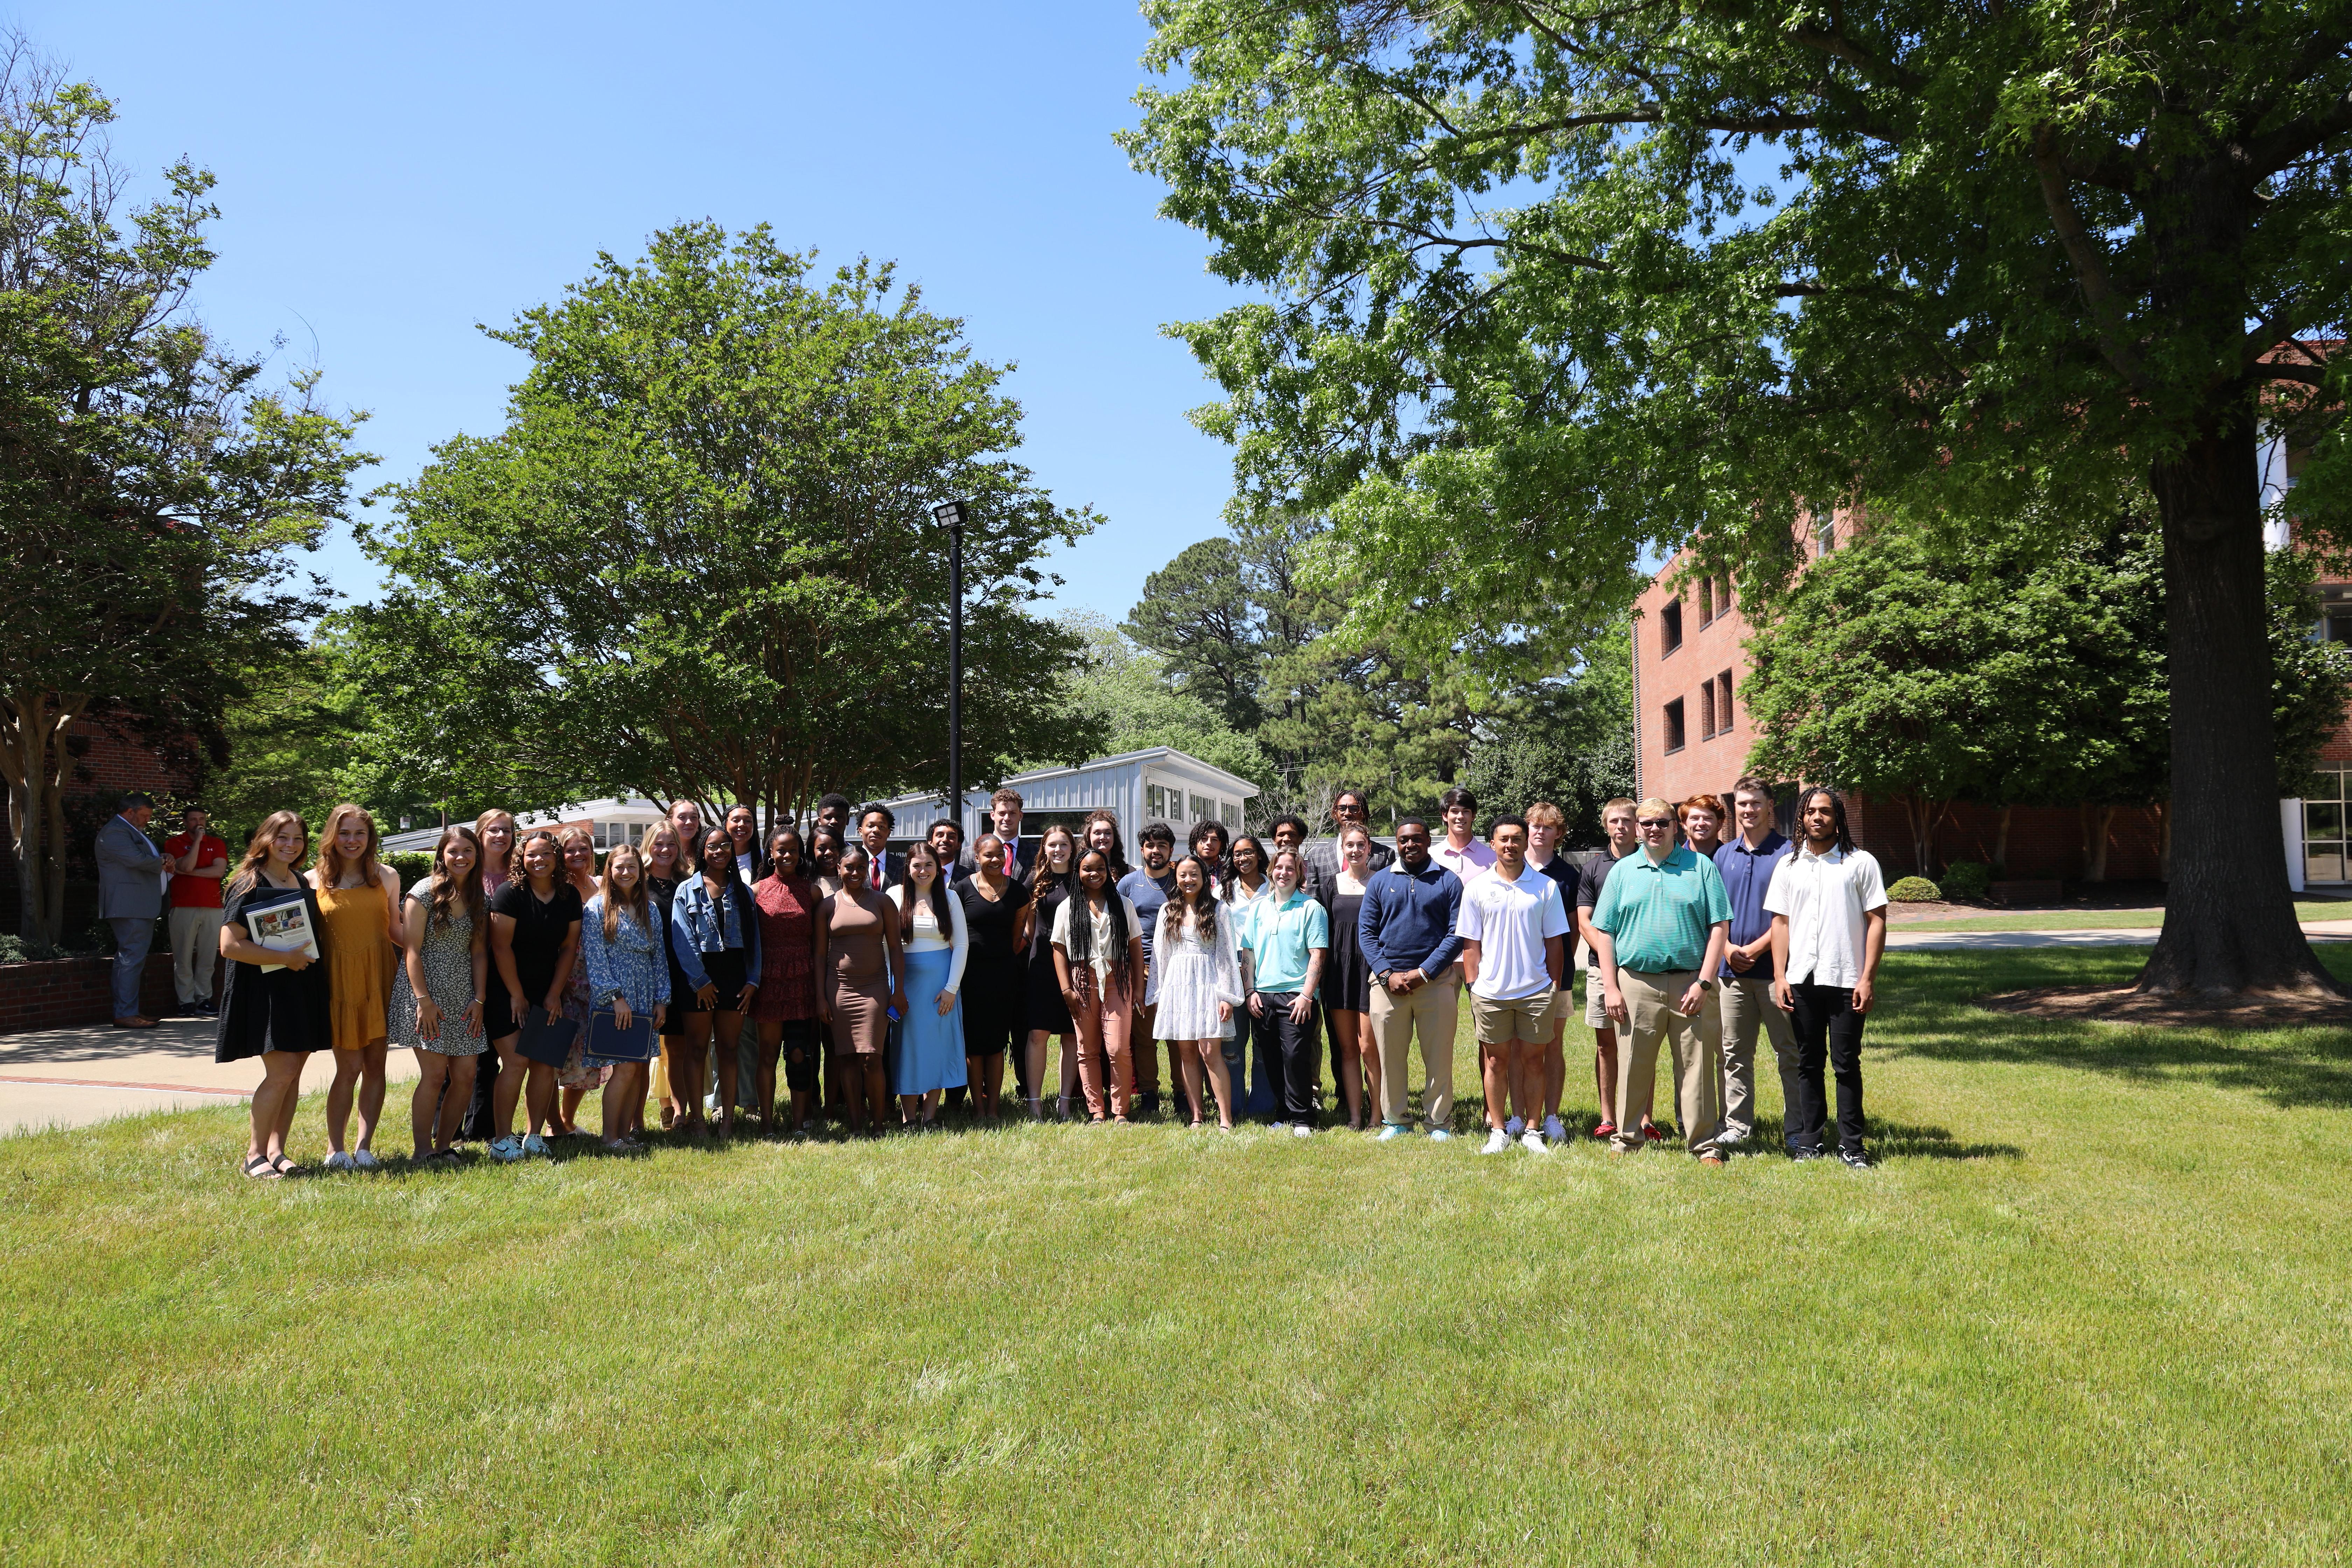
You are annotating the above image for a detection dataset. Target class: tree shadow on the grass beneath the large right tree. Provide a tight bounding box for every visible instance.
[1863,947,2352,1110]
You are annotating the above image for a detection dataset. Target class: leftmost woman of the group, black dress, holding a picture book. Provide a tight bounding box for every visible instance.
[212,811,334,1180]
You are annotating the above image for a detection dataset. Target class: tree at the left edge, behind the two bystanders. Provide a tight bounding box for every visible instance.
[0,37,369,952]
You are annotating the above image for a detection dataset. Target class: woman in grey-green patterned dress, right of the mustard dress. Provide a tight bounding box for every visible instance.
[393,823,489,1166]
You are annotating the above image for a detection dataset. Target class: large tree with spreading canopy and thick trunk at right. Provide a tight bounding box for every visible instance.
[1127,0,2352,990]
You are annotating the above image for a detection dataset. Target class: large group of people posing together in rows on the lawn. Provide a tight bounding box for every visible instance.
[106,778,1886,1180]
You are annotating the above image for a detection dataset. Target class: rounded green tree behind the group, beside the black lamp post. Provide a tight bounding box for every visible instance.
[355,223,1094,818]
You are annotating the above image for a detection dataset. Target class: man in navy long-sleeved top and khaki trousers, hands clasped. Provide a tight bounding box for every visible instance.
[1355,816,1463,1142]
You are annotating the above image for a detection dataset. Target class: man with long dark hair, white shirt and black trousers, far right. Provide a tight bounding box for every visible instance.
[1764,790,1886,1171]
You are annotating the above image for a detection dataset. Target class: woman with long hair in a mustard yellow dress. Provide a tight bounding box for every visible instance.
[306,802,400,1171]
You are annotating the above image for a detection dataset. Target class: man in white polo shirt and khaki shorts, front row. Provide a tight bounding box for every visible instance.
[1461,816,1569,1154]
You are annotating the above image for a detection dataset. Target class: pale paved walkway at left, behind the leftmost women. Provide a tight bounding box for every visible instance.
[0,1018,416,1138]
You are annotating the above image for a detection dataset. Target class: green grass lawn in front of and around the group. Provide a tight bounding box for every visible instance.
[0,950,2352,1566]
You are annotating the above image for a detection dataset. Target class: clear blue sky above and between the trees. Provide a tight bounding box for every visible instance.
[27,0,1232,616]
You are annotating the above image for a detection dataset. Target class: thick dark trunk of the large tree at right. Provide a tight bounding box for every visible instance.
[2138,414,2345,994]
